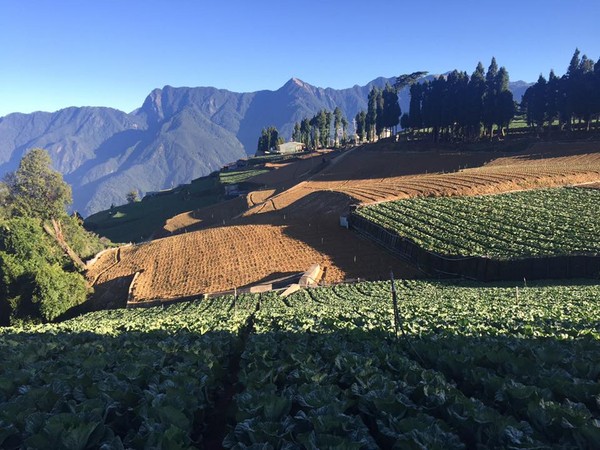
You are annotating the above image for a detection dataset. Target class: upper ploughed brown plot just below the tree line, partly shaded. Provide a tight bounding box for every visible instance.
[247,143,600,215]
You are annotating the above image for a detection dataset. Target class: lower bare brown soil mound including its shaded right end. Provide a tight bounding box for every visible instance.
[93,223,417,302]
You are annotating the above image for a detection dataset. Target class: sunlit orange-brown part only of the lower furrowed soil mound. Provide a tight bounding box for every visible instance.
[92,225,350,303]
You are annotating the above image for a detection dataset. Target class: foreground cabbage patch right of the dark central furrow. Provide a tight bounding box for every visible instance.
[225,281,600,449]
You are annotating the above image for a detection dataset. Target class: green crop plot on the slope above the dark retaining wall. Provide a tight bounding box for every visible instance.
[357,188,600,260]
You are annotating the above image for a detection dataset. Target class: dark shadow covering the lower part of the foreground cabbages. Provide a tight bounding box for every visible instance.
[0,318,600,449]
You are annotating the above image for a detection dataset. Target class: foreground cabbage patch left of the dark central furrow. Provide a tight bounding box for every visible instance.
[0,297,257,449]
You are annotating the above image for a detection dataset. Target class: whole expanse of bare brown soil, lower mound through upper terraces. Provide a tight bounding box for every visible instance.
[90,143,600,302]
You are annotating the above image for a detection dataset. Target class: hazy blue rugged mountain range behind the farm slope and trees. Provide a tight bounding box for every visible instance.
[0,77,530,216]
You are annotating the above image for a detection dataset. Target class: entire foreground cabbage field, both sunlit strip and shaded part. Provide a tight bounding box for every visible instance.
[0,281,600,449]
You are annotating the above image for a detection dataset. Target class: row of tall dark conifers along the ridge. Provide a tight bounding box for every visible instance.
[259,49,600,149]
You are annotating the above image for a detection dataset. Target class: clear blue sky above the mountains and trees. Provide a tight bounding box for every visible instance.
[0,0,600,116]
